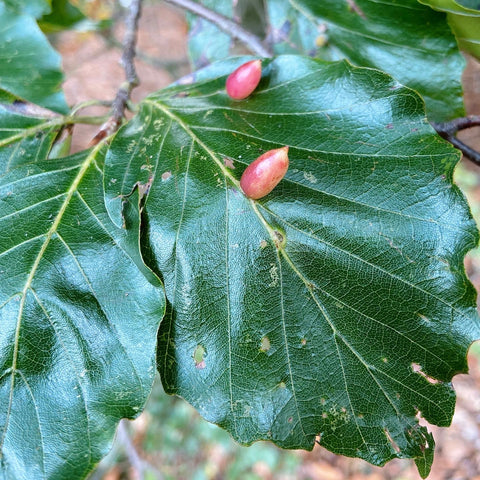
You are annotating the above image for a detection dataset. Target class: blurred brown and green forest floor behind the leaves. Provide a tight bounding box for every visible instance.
[55,4,480,480]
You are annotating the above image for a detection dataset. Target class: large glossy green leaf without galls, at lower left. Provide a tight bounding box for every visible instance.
[0,136,164,480]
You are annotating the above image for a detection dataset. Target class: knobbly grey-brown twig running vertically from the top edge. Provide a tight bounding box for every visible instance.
[112,0,142,128]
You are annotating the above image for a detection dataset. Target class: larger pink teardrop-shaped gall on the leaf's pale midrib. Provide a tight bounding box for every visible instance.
[240,147,288,200]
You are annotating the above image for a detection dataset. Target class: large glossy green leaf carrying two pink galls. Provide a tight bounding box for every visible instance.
[104,56,480,476]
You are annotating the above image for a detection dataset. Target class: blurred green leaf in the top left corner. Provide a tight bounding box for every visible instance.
[0,2,68,113]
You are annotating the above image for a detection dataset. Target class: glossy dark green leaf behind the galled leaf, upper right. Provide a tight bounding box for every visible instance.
[267,0,465,121]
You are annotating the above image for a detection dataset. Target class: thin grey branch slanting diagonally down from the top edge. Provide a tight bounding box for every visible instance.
[166,0,272,57]
